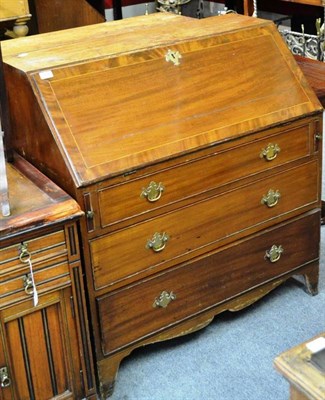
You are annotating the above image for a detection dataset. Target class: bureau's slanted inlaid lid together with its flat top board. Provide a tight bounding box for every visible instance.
[3,13,322,186]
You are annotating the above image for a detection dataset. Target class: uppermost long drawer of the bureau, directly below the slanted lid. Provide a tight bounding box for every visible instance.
[98,124,313,228]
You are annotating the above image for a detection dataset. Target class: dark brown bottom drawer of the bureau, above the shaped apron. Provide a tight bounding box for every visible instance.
[97,212,320,355]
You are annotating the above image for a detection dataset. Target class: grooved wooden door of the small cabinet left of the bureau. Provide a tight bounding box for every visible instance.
[0,288,81,400]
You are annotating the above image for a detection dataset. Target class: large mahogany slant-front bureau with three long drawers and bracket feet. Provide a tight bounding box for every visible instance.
[3,13,322,398]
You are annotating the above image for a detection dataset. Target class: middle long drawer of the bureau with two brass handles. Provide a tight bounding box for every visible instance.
[90,160,319,289]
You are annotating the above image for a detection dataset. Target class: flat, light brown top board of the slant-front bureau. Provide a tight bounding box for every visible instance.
[2,13,269,72]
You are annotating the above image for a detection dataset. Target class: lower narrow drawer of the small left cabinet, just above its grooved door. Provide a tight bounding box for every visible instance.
[0,262,71,308]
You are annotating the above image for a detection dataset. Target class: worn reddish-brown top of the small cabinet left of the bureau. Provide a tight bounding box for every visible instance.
[0,156,82,239]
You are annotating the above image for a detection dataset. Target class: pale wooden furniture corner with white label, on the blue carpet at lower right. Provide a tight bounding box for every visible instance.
[274,332,325,400]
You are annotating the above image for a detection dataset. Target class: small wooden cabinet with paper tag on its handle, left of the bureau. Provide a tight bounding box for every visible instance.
[0,156,95,400]
